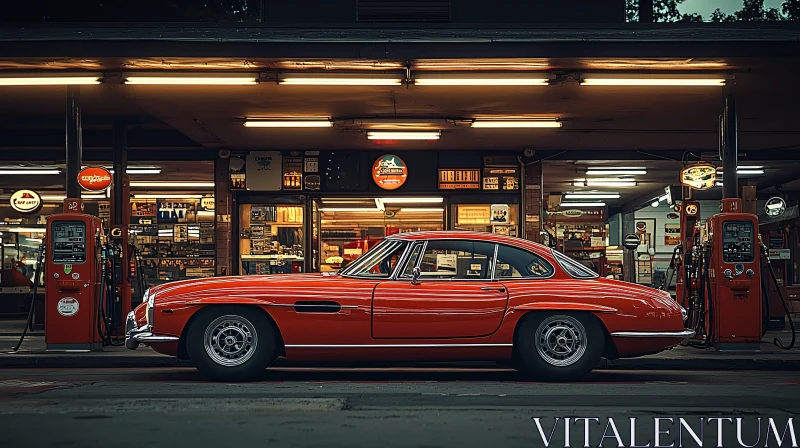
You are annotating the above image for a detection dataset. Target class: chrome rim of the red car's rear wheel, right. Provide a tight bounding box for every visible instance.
[536,316,586,367]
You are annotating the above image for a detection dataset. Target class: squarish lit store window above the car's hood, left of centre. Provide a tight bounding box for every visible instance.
[239,204,305,275]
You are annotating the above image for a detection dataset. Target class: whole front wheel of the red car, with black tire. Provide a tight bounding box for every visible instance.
[186,306,277,382]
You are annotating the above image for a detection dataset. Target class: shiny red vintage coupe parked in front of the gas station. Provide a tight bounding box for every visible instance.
[126,232,693,381]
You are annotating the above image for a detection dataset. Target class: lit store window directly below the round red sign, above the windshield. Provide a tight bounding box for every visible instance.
[318,197,444,272]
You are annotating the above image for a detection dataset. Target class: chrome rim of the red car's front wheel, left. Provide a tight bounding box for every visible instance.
[203,315,258,367]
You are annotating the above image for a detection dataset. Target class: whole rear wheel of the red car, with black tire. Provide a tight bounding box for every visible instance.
[516,311,605,381]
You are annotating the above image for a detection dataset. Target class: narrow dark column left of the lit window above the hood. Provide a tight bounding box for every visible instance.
[214,158,233,275]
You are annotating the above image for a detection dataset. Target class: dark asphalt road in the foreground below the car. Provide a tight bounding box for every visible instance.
[0,368,800,448]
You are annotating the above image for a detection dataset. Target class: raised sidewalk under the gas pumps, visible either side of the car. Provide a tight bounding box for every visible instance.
[0,320,800,371]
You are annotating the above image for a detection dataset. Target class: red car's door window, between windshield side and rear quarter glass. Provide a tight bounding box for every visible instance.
[412,240,494,280]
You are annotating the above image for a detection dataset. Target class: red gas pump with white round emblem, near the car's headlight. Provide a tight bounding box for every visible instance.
[44,199,103,351]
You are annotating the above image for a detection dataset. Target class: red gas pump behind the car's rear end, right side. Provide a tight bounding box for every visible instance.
[701,198,763,350]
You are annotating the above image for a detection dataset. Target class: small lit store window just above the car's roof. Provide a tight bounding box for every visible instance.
[453,204,519,236]
